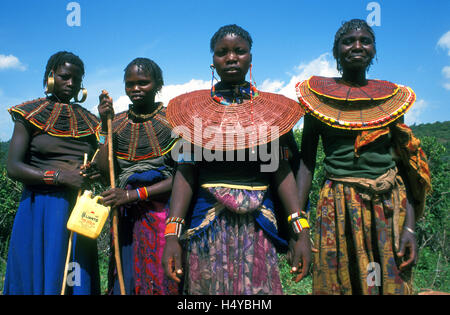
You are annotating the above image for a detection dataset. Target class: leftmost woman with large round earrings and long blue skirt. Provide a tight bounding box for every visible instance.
[4,51,100,294]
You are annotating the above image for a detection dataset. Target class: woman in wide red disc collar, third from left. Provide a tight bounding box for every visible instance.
[163,25,311,295]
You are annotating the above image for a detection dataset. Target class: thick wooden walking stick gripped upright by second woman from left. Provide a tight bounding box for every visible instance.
[107,117,125,295]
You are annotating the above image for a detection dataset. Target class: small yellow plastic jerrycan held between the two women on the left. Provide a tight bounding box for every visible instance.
[67,190,110,239]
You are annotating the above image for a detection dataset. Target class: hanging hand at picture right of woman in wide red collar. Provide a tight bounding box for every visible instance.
[287,229,312,282]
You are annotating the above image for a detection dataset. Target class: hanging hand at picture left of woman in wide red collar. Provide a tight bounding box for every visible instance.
[162,236,183,283]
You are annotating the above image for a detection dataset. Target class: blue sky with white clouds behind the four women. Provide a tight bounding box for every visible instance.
[0,0,450,141]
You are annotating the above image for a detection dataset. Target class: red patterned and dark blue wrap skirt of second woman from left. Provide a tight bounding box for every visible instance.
[109,170,180,295]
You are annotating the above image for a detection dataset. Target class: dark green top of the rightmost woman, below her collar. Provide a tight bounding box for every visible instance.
[301,114,395,179]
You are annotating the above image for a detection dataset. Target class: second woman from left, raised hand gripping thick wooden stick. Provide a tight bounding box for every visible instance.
[99,58,179,295]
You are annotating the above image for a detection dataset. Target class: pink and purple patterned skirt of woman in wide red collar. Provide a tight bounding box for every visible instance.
[184,188,283,295]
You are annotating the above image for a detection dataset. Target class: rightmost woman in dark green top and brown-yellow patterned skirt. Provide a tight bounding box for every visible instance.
[296,19,430,294]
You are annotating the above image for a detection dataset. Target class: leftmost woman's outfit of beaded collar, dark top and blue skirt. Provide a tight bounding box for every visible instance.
[3,99,100,295]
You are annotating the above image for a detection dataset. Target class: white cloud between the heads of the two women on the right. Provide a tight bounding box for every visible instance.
[259,53,339,100]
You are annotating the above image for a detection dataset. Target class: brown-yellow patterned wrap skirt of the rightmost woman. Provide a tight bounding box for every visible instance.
[313,176,412,295]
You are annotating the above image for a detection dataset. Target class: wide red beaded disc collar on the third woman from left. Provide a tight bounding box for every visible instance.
[167,90,305,151]
